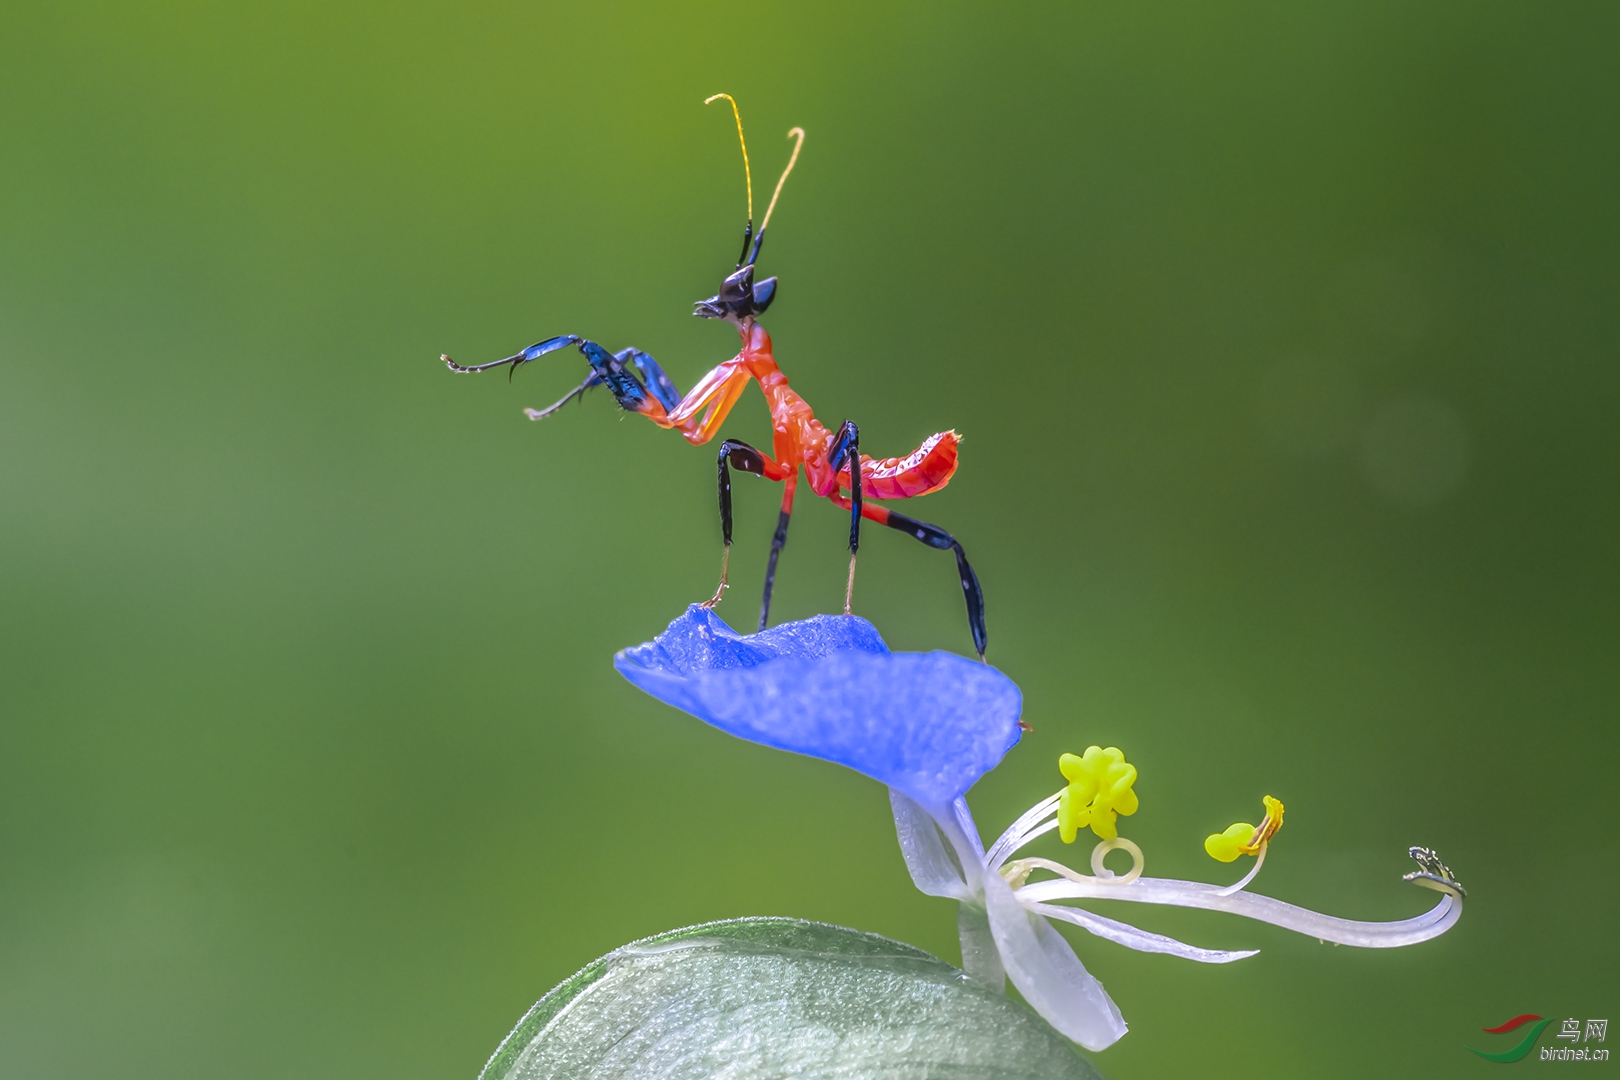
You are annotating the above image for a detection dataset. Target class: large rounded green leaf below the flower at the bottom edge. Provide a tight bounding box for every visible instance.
[481,918,1097,1080]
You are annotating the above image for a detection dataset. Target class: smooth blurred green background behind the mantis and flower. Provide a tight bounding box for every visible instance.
[0,2,1620,1080]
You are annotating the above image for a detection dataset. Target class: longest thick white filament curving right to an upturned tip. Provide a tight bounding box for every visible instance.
[1019,878,1463,949]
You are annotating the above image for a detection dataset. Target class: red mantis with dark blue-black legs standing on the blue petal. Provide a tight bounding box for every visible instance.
[442,96,987,657]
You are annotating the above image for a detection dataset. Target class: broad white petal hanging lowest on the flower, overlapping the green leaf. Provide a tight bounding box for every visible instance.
[985,874,1126,1051]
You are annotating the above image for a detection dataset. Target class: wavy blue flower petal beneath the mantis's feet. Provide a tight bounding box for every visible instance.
[614,604,1024,810]
